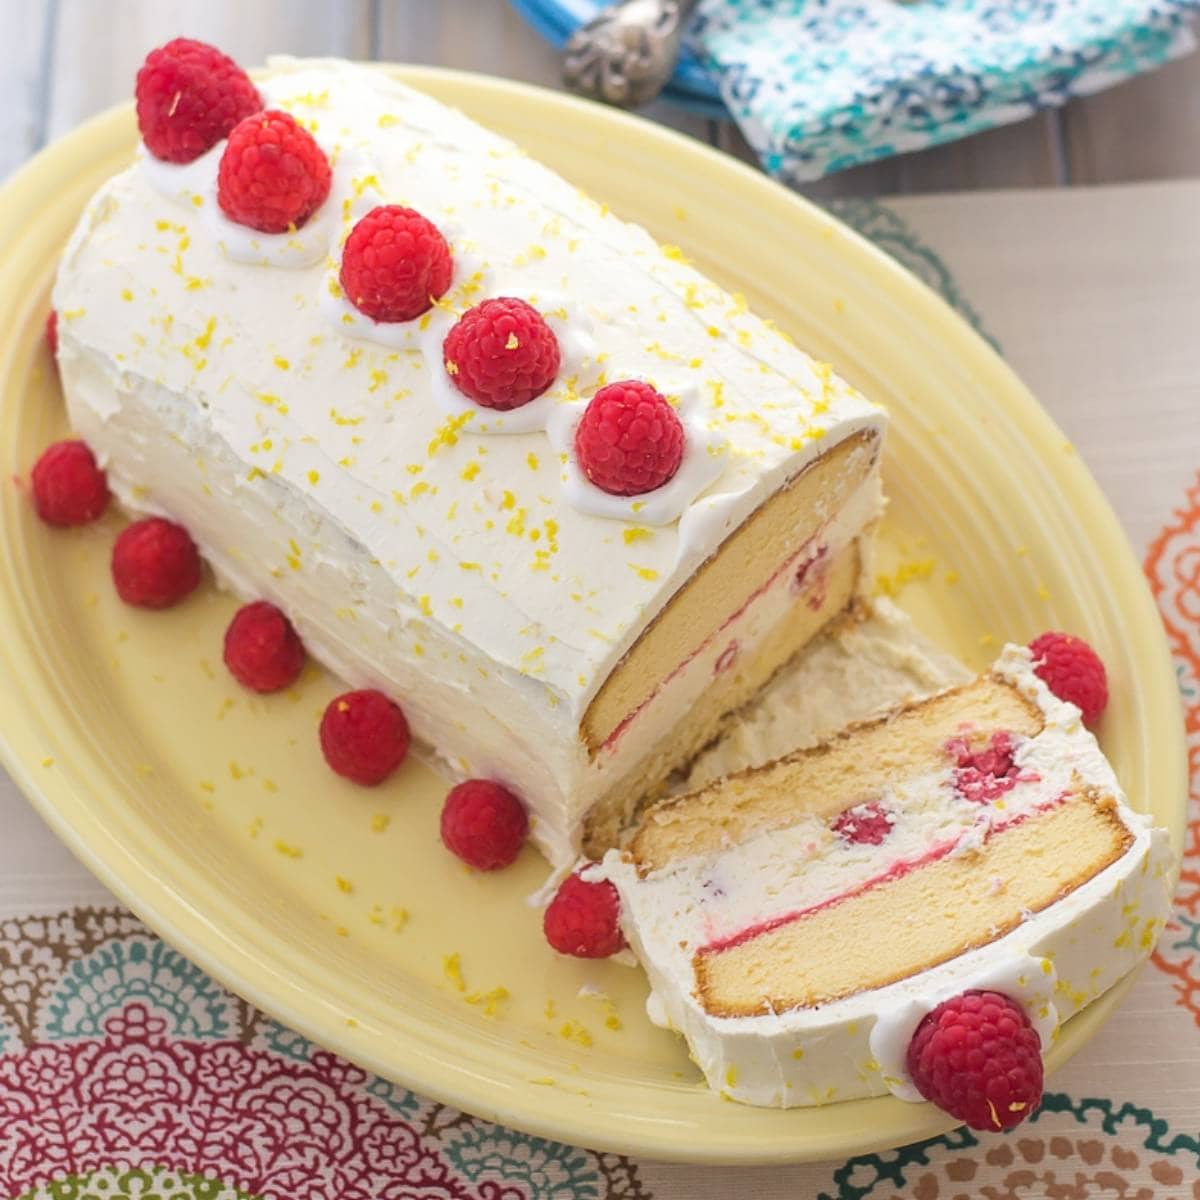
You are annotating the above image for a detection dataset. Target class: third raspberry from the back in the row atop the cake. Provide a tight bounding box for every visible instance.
[340,204,454,322]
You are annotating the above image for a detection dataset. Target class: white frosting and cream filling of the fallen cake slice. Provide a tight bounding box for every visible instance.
[601,646,1172,1106]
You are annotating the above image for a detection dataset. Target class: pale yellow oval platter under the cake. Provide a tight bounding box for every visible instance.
[0,68,1186,1163]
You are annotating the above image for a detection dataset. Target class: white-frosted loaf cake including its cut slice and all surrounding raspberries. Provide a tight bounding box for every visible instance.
[31,40,1171,1129]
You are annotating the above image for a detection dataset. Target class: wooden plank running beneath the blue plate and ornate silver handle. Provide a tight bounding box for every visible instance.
[376,0,709,140]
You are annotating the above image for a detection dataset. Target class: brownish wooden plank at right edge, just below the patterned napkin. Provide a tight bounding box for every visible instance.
[1064,54,1200,184]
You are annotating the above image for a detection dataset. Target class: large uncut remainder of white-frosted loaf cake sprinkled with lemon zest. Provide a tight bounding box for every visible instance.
[54,60,884,865]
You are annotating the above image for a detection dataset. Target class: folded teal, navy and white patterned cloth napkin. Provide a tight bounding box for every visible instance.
[691,0,1200,184]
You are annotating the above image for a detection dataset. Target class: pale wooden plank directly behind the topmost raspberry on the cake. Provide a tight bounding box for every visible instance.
[44,0,371,137]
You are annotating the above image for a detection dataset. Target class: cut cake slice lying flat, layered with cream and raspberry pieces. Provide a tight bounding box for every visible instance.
[599,647,1171,1106]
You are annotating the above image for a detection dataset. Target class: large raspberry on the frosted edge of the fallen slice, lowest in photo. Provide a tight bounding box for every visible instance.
[907,991,1043,1132]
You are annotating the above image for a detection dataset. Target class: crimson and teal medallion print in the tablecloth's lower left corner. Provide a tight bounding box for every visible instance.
[0,908,648,1200]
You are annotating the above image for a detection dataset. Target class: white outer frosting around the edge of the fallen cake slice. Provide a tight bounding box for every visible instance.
[599,647,1172,1108]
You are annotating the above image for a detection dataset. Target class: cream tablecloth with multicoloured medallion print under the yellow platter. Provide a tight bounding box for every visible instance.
[0,182,1200,1200]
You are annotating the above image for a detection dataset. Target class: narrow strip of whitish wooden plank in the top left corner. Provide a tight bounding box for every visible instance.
[0,0,53,179]
